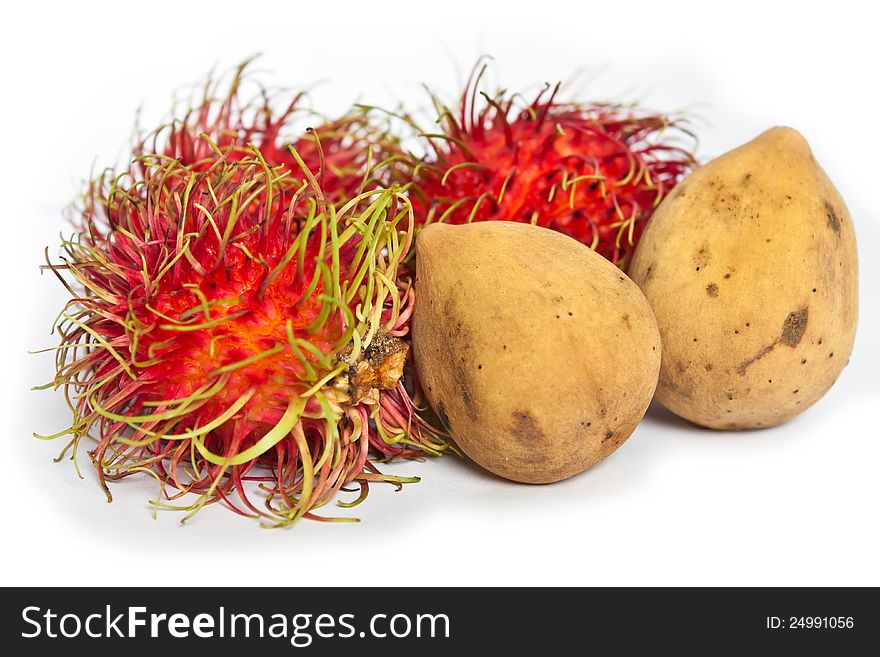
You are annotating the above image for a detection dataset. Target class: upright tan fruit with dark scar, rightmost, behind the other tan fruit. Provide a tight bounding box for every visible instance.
[629,128,858,429]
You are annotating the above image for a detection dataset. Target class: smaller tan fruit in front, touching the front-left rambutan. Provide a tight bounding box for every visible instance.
[413,221,660,483]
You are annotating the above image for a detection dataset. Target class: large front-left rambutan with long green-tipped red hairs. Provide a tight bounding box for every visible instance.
[43,135,448,526]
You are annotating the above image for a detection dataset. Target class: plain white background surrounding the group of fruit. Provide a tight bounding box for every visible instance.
[0,0,880,585]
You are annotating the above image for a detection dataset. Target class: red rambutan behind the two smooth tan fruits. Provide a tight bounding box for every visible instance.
[403,65,694,269]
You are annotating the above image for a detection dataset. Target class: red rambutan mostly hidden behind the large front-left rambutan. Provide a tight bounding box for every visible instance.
[79,59,399,247]
